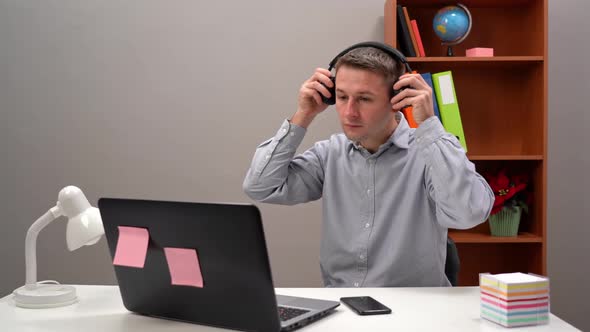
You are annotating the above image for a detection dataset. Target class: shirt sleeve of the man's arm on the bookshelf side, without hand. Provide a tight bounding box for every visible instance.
[415,116,494,229]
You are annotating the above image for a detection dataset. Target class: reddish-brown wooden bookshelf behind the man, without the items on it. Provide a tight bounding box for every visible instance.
[384,0,548,285]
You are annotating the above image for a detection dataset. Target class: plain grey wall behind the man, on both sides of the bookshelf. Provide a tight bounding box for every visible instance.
[0,0,590,329]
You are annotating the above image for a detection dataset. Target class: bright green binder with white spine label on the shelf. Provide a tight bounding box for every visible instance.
[432,71,467,152]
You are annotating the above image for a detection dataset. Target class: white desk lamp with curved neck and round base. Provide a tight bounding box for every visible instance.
[13,186,104,308]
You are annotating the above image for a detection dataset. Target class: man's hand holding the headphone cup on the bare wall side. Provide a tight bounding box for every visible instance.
[291,68,333,128]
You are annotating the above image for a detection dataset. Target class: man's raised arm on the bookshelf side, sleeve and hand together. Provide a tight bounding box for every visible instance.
[391,74,494,229]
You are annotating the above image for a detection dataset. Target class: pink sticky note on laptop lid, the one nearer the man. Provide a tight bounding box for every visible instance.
[164,248,203,288]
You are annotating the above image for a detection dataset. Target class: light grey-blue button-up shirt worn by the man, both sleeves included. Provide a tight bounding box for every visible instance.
[243,112,494,287]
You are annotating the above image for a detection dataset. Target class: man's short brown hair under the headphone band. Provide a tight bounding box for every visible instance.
[334,46,405,91]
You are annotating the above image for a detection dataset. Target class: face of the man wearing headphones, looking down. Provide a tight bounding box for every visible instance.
[336,66,397,151]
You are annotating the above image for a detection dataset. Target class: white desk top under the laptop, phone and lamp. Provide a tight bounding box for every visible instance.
[0,286,578,332]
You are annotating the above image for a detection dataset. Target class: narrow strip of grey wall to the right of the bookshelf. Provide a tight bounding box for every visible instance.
[547,0,590,331]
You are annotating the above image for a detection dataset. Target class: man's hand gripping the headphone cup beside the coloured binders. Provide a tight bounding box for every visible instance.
[391,74,434,125]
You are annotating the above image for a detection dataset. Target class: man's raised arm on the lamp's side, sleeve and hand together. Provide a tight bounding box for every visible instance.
[243,68,333,205]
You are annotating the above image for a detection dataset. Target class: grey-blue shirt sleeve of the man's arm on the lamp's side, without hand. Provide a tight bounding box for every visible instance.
[243,120,327,205]
